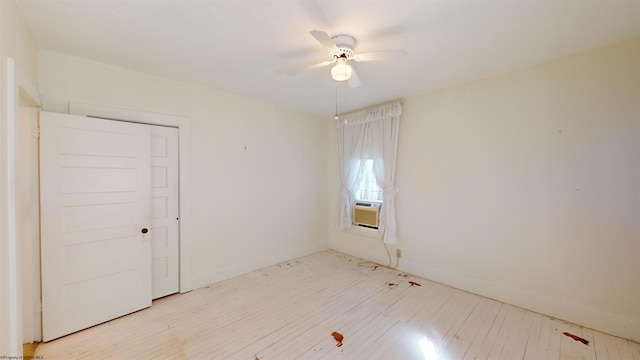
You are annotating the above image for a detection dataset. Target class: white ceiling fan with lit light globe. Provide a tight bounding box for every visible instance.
[286,30,407,87]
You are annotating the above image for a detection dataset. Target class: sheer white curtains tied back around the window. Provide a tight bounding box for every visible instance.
[337,102,402,244]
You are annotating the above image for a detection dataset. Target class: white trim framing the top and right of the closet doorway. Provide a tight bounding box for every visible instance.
[69,101,193,293]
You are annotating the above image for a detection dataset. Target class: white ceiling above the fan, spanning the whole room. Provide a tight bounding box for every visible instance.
[13,0,640,116]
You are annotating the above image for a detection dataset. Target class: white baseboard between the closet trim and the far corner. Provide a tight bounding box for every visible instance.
[192,246,328,289]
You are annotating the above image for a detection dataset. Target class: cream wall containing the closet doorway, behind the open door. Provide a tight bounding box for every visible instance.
[40,51,331,287]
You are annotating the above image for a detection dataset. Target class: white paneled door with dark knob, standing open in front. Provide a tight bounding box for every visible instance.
[40,112,151,341]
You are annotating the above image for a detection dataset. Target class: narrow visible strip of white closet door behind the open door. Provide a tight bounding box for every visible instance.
[150,126,180,299]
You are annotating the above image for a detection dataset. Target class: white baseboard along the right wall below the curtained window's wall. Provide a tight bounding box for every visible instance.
[398,259,640,342]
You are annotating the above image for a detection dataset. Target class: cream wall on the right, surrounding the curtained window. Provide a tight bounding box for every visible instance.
[330,38,640,341]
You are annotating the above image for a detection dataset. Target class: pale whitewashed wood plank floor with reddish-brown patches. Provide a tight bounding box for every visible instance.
[36,251,640,360]
